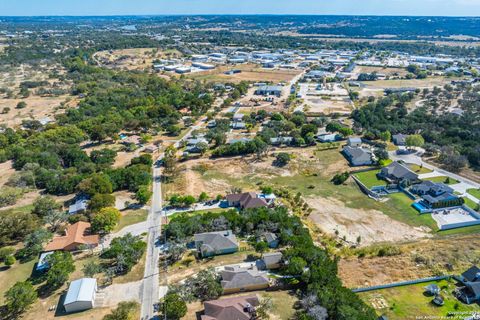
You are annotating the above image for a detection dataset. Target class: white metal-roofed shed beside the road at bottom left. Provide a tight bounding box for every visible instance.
[63,278,97,313]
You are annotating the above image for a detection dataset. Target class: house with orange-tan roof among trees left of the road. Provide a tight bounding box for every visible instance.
[45,221,100,251]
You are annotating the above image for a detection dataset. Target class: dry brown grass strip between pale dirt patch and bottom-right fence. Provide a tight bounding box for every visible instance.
[339,235,480,288]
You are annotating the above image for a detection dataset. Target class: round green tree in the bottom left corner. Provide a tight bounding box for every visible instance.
[5,281,38,316]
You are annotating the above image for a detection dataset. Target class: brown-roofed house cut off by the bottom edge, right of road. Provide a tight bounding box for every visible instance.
[201,295,260,320]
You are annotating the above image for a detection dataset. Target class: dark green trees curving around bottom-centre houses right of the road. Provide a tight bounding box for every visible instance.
[165,207,375,320]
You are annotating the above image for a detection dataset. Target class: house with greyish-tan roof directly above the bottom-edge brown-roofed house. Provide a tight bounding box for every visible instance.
[221,266,270,294]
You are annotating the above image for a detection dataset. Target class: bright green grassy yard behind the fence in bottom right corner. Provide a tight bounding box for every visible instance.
[359,280,480,320]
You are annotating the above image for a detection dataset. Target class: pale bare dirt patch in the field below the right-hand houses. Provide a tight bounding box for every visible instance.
[307,197,431,246]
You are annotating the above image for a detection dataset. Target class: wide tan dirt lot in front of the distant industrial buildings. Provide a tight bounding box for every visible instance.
[188,64,301,83]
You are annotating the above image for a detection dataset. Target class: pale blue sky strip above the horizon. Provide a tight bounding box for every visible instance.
[0,0,480,16]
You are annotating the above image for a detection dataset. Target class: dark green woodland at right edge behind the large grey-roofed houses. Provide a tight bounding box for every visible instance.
[352,88,480,171]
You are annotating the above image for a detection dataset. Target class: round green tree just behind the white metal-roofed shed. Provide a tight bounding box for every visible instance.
[46,251,75,290]
